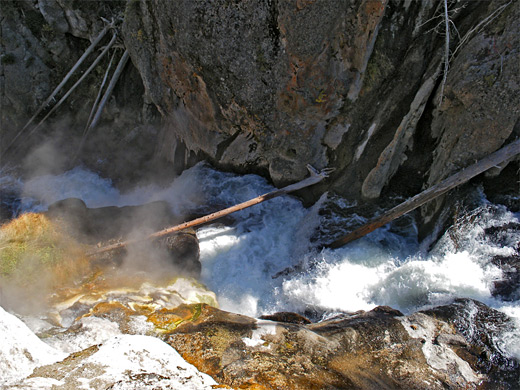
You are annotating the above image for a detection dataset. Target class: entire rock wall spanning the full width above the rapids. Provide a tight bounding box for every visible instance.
[2,0,520,229]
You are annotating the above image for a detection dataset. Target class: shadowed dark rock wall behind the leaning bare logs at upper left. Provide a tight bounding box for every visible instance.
[0,0,159,181]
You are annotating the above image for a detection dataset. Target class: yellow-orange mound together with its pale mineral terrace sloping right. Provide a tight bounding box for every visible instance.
[0,213,218,333]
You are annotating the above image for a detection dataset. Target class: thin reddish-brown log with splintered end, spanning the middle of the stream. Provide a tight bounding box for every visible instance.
[87,165,333,257]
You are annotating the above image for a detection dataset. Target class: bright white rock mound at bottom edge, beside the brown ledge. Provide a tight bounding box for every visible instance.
[12,335,217,390]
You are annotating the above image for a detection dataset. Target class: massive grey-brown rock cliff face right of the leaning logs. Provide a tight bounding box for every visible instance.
[124,0,519,204]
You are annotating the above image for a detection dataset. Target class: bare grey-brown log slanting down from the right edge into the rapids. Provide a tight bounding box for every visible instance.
[325,139,520,249]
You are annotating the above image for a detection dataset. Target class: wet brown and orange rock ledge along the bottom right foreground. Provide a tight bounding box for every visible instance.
[149,300,518,389]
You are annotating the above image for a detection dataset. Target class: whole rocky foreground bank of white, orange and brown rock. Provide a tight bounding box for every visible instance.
[2,280,520,389]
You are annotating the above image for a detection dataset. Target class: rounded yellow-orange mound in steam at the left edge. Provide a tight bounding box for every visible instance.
[0,213,91,313]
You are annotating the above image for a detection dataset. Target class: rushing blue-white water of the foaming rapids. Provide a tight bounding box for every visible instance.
[3,164,520,368]
